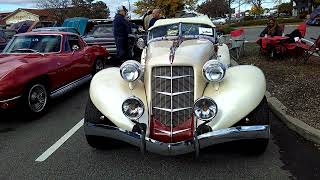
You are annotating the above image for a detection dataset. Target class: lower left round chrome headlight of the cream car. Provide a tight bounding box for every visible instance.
[122,96,144,121]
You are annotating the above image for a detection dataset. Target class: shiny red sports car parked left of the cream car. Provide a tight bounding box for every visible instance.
[0,32,108,116]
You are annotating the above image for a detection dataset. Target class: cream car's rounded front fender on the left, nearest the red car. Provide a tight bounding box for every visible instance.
[90,68,149,131]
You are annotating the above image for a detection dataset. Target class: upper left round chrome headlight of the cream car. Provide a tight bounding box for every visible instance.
[120,60,142,82]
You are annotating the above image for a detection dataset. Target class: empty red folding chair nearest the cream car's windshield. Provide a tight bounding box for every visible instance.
[229,28,246,61]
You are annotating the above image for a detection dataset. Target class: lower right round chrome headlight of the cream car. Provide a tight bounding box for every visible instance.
[193,97,218,121]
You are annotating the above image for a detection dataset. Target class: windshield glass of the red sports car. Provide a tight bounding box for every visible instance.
[4,35,61,53]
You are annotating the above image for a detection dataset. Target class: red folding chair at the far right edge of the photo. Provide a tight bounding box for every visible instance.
[297,36,320,63]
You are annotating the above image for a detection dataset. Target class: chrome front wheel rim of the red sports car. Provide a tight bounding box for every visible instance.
[27,84,48,113]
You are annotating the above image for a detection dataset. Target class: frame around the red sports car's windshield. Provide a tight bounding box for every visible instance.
[2,34,64,54]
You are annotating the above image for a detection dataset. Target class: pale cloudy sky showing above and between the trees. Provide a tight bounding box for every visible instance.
[0,0,286,14]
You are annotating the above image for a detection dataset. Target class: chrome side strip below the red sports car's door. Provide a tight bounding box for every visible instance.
[50,75,92,98]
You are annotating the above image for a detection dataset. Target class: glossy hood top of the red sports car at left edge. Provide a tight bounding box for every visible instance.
[0,54,39,80]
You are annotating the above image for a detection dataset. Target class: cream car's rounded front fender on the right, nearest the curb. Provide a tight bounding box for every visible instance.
[204,65,266,130]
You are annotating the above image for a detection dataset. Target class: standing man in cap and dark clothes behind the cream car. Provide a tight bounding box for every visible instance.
[112,6,131,63]
